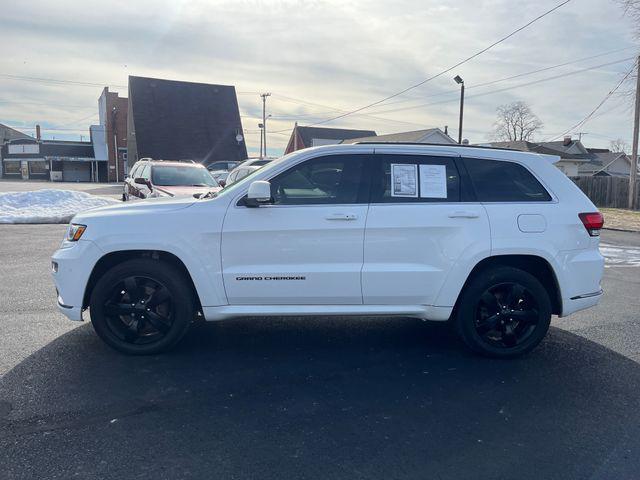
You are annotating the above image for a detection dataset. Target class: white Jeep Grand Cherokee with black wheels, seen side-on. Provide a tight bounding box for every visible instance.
[53,144,604,357]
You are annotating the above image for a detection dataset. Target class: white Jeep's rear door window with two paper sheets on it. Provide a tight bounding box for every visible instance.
[371,153,460,203]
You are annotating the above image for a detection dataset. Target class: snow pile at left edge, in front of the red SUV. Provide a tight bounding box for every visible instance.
[0,190,118,223]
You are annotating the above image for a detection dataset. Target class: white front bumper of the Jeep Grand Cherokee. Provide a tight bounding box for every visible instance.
[51,239,104,321]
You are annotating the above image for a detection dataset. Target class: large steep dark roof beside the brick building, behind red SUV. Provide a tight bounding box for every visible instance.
[129,76,247,165]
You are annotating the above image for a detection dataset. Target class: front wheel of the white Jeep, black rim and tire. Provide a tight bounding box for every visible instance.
[89,258,196,355]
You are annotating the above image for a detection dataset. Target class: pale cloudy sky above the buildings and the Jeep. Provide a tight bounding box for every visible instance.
[0,0,639,154]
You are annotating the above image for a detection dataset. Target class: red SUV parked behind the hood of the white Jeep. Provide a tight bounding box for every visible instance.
[122,159,222,201]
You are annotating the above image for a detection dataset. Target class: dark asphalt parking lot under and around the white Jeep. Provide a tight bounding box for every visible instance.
[0,225,640,480]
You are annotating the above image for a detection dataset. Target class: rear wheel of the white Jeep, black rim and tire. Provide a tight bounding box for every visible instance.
[454,267,551,358]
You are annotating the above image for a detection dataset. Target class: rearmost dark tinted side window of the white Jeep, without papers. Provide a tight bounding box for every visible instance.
[463,158,551,202]
